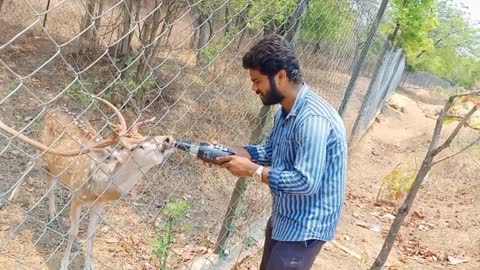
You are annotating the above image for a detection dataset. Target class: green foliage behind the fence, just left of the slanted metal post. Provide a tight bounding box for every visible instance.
[299,0,356,44]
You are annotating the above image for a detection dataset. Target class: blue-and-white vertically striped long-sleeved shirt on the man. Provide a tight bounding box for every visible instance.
[245,84,347,241]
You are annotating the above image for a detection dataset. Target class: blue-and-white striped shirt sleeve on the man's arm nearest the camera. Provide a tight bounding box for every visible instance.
[268,115,332,195]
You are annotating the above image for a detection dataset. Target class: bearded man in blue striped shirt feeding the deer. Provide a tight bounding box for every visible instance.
[219,35,347,270]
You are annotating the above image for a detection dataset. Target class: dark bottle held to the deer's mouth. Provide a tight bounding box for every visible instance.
[175,140,235,165]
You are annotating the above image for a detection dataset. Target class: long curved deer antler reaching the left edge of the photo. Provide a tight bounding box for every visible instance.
[0,121,117,157]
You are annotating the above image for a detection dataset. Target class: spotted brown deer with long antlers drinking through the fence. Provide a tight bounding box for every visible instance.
[0,96,175,270]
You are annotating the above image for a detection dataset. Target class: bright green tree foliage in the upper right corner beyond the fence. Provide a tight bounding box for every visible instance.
[390,0,480,88]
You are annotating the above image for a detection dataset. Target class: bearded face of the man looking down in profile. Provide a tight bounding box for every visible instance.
[249,69,284,105]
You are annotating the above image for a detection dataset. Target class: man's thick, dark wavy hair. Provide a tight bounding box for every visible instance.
[242,34,302,83]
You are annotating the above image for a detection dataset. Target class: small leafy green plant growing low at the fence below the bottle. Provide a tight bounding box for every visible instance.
[152,199,189,270]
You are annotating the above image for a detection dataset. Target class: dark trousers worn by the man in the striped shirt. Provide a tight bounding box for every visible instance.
[260,219,325,270]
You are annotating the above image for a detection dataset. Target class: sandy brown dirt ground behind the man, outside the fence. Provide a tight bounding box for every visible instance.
[237,89,480,270]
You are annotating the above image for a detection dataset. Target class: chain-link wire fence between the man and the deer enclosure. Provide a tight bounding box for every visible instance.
[0,0,412,269]
